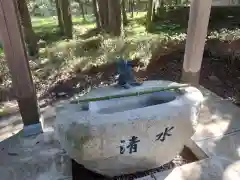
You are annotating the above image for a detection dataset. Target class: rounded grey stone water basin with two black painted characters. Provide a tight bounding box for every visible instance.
[56,81,203,176]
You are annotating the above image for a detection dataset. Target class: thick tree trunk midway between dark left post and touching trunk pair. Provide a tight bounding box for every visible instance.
[59,0,73,39]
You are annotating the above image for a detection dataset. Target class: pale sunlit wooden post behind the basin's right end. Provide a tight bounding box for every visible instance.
[182,0,212,86]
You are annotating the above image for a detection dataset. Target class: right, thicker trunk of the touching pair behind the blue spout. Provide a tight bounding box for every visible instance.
[108,0,122,36]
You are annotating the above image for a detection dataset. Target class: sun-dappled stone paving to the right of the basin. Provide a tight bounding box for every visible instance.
[138,88,240,180]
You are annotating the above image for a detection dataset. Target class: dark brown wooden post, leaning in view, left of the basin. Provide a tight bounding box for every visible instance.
[0,0,39,127]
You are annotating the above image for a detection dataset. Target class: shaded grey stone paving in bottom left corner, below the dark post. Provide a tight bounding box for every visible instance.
[0,129,71,180]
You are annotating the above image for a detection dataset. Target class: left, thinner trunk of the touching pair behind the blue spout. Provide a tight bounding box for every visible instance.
[98,0,109,32]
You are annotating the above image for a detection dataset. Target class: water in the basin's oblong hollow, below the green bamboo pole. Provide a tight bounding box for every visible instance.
[89,91,179,114]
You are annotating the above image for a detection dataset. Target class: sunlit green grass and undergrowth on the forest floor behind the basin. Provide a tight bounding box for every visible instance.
[0,7,240,97]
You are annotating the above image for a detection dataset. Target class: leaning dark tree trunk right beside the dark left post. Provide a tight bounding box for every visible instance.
[17,0,38,56]
